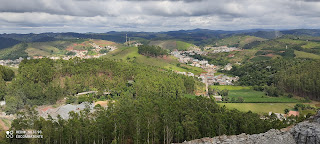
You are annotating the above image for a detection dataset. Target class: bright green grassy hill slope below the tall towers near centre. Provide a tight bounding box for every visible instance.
[106,47,203,74]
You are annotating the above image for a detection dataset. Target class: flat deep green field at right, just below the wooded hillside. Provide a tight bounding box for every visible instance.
[211,86,301,103]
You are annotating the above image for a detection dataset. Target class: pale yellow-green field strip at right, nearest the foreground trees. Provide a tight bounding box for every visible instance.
[218,103,296,114]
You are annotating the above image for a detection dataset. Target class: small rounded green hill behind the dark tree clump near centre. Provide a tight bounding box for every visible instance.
[149,40,194,51]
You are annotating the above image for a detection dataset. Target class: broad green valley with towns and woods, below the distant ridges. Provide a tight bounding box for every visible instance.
[0,29,320,142]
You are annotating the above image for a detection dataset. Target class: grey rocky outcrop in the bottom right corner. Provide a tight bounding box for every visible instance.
[178,111,320,144]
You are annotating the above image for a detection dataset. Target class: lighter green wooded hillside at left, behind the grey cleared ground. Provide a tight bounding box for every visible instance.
[6,58,195,113]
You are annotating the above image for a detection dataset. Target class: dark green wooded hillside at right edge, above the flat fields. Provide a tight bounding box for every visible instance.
[224,58,320,100]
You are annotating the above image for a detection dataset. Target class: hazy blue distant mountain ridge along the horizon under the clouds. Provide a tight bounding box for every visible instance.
[0,29,320,43]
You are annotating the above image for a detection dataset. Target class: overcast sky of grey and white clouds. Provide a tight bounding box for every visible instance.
[0,0,320,33]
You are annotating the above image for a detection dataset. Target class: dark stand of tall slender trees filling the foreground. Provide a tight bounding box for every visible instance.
[7,95,287,144]
